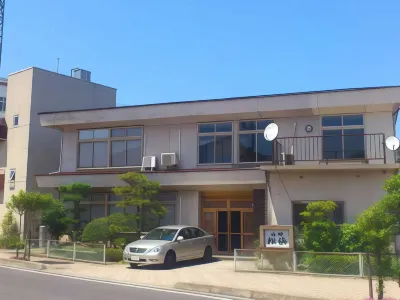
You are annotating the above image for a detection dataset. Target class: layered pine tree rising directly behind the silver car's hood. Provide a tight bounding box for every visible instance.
[112,172,167,233]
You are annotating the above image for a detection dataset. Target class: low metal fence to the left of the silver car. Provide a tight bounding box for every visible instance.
[25,240,106,264]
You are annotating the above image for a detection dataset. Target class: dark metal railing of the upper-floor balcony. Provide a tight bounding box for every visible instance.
[273,133,386,164]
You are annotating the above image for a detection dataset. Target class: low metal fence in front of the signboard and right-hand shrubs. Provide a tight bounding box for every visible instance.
[234,249,400,278]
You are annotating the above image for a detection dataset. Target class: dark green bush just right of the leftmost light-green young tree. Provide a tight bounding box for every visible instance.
[41,200,78,239]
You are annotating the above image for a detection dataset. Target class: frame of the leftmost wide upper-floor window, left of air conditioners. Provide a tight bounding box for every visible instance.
[76,126,144,170]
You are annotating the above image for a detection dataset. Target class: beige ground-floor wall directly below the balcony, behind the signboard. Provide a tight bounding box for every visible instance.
[268,171,392,225]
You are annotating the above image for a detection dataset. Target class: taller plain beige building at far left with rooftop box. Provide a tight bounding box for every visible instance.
[0,67,116,236]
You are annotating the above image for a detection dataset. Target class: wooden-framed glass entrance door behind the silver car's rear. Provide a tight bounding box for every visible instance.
[202,191,254,253]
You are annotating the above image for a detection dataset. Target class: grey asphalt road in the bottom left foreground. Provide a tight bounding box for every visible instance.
[0,266,238,300]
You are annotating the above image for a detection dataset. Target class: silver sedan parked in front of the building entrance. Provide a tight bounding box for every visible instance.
[124,225,215,268]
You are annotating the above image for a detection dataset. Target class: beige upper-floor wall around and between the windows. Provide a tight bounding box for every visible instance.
[54,112,394,172]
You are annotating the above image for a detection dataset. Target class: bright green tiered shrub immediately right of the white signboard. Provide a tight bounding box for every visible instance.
[300,200,338,252]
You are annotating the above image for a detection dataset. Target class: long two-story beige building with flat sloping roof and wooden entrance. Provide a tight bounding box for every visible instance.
[36,87,400,252]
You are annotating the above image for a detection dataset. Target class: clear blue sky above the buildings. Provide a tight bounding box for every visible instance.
[0,0,400,127]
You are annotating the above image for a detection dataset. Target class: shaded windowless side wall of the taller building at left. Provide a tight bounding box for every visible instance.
[28,69,116,189]
